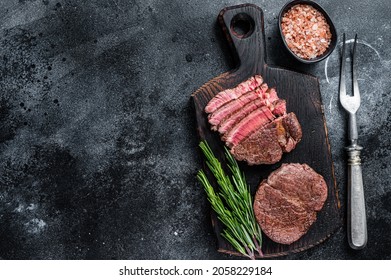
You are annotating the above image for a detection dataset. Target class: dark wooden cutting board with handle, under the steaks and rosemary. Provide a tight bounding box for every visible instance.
[192,4,342,257]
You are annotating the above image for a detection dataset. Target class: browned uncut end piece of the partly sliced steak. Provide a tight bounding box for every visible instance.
[231,113,302,165]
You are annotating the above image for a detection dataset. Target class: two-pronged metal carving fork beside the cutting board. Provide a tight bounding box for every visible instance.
[339,34,368,249]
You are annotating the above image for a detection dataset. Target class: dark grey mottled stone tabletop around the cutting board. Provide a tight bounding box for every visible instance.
[0,0,391,259]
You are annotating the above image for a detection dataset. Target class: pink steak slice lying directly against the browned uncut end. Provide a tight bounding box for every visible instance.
[224,106,275,148]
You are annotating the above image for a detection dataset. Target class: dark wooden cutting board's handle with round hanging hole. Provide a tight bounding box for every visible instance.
[218,4,266,76]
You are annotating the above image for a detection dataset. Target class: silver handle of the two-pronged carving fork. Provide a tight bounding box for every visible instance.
[347,145,368,249]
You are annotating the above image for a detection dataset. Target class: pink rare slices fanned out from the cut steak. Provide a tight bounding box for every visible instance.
[205,75,295,155]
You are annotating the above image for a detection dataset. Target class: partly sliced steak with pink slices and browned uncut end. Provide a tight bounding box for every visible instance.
[205,75,302,165]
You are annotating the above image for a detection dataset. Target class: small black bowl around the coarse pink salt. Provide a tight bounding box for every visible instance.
[278,0,338,64]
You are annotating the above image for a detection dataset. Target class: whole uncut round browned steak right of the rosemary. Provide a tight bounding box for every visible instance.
[254,163,327,244]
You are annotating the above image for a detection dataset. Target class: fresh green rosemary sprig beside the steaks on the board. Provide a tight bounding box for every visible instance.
[197,141,262,259]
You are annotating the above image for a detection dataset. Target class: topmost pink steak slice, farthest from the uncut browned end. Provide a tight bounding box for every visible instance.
[205,75,263,113]
